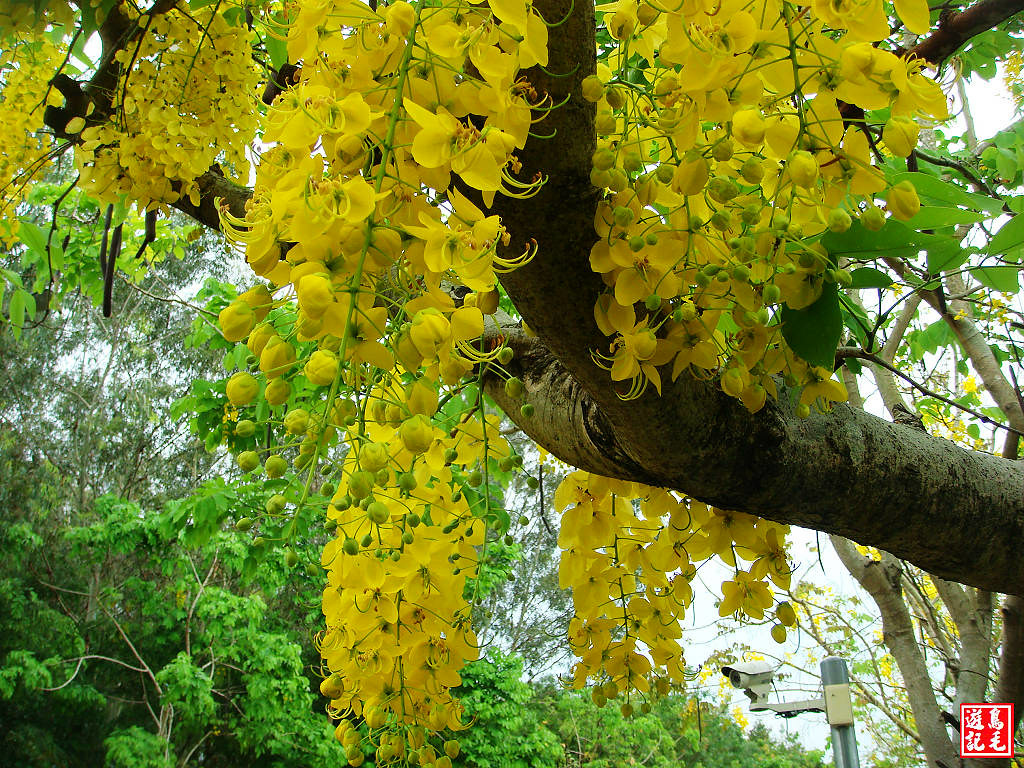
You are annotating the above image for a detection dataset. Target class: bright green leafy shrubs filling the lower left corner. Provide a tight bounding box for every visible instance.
[0,423,343,768]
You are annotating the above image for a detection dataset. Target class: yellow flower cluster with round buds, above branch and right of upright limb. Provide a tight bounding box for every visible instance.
[584,0,946,411]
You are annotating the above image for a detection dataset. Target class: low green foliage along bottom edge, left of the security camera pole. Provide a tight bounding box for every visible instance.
[454,649,822,768]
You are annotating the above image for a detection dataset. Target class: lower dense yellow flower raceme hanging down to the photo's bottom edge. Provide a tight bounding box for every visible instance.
[319,381,509,764]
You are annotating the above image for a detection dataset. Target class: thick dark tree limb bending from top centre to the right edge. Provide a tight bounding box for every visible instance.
[74,0,1024,594]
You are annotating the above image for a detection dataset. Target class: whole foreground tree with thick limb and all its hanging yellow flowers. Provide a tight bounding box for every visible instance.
[0,0,1024,768]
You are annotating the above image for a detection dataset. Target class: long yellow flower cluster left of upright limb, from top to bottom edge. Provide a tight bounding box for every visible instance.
[220,0,547,753]
